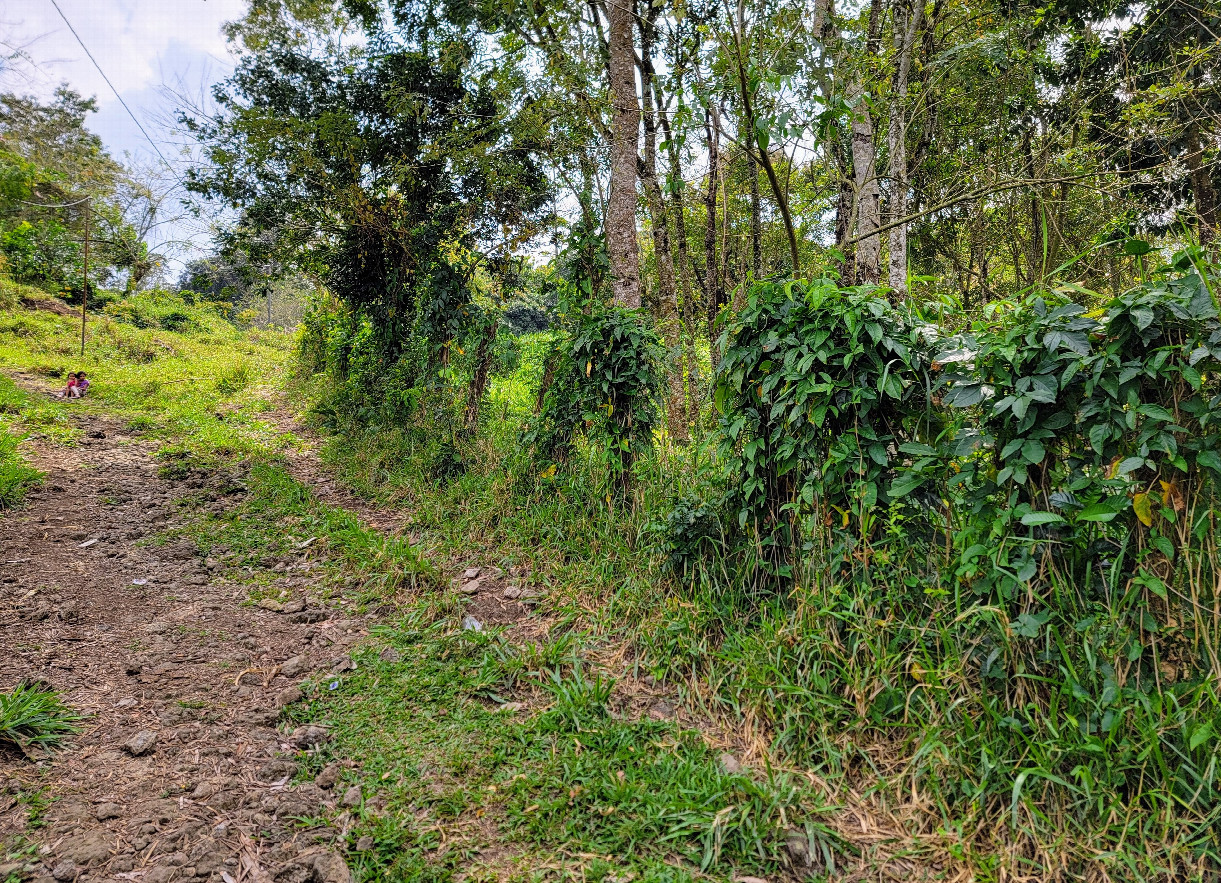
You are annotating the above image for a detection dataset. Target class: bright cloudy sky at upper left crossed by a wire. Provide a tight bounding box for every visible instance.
[0,0,245,278]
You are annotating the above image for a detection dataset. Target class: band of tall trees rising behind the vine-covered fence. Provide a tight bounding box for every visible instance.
[187,0,1221,440]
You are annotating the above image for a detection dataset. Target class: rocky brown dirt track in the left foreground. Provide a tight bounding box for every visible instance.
[0,403,370,883]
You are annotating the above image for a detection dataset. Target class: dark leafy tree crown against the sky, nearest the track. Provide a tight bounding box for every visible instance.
[186,4,549,354]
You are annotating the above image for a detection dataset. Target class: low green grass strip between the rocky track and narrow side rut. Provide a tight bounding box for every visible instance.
[180,465,847,881]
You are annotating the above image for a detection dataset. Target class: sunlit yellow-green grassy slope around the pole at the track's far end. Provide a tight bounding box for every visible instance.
[0,284,292,459]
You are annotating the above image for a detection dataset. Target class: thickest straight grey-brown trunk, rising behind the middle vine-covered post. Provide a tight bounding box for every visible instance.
[606,0,640,309]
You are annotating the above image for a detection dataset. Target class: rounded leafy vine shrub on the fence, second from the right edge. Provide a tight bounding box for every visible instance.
[714,280,941,561]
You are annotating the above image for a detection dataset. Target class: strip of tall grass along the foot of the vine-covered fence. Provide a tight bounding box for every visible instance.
[290,332,1221,881]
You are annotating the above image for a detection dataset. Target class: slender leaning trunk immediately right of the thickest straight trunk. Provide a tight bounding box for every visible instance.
[640,5,690,443]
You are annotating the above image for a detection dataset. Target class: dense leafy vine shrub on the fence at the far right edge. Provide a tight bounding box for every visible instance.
[937,256,1221,596]
